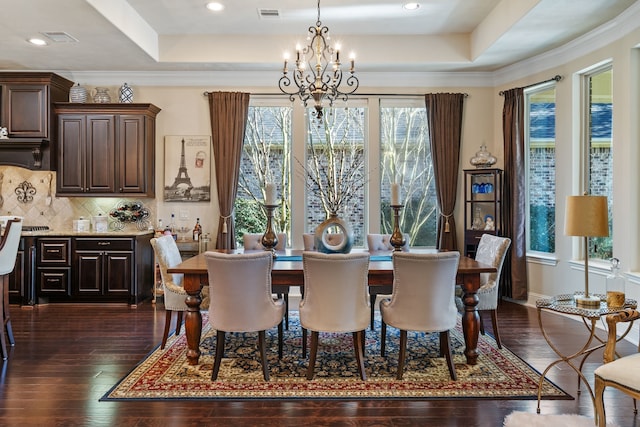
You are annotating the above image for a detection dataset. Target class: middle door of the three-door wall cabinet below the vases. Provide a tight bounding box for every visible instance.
[86,114,116,193]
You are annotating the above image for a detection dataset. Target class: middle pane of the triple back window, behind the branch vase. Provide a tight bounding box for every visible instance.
[305,107,367,246]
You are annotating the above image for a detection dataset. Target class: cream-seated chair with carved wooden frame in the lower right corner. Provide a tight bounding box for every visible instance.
[593,308,640,427]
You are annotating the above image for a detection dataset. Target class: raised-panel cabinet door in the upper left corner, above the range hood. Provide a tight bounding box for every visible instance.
[2,83,49,139]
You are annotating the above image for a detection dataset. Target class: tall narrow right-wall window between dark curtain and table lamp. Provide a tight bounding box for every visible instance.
[525,84,556,253]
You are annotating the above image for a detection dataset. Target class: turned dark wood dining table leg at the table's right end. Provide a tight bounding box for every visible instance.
[462,273,480,365]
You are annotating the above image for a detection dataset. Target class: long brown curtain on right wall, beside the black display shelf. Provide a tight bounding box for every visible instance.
[500,88,528,300]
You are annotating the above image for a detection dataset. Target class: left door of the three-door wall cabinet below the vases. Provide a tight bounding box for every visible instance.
[56,114,87,194]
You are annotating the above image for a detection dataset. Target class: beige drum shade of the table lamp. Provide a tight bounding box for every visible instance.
[564,196,609,237]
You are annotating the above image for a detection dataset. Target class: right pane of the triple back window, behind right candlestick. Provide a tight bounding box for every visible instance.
[380,104,437,247]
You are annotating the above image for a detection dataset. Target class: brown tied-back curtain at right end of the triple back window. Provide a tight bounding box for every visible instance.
[425,93,464,251]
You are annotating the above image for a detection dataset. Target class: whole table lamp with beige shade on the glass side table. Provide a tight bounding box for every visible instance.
[564,194,609,307]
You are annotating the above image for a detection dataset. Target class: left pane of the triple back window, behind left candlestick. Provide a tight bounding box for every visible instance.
[235,106,291,243]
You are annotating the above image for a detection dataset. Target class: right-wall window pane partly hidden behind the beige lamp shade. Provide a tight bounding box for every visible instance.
[588,68,613,259]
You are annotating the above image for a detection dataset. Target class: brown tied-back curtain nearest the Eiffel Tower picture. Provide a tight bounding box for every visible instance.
[209,92,249,249]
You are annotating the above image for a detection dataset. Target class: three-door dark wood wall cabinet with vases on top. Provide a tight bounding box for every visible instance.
[55,103,160,197]
